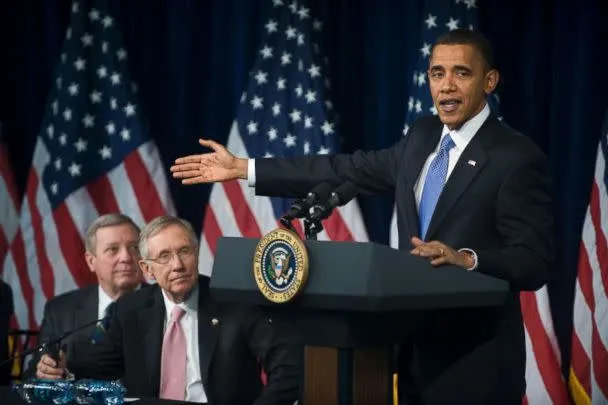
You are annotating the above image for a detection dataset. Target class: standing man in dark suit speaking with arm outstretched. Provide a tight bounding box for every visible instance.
[171,30,553,404]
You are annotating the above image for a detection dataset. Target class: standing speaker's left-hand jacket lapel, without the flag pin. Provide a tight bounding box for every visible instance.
[400,120,443,238]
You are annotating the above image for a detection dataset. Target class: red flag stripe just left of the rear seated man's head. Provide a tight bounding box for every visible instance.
[53,203,96,287]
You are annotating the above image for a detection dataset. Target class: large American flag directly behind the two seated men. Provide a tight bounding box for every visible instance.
[3,1,174,329]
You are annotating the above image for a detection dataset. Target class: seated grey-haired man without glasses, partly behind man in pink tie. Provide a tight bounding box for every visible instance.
[25,213,143,377]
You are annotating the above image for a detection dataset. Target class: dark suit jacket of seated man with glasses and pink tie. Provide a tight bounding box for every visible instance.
[68,275,300,405]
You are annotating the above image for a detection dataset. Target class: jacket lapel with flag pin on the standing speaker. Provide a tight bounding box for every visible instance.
[427,123,491,240]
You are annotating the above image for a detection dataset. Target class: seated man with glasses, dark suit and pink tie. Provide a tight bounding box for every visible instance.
[38,217,300,405]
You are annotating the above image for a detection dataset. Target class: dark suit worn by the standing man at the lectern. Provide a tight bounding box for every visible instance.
[256,116,553,404]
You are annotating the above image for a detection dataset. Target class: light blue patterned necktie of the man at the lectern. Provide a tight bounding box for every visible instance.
[418,134,454,239]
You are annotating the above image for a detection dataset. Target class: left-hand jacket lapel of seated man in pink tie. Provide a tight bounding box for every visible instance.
[138,287,166,396]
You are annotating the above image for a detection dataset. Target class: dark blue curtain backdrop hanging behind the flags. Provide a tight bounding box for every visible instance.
[0,0,608,372]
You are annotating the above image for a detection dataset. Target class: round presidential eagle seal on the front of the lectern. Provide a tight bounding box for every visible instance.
[253,229,308,304]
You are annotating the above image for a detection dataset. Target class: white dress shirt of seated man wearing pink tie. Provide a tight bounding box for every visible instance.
[161,286,207,403]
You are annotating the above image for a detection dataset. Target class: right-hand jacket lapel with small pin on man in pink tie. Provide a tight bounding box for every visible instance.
[198,279,222,400]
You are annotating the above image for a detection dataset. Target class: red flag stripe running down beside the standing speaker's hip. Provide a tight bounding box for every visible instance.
[519,292,568,404]
